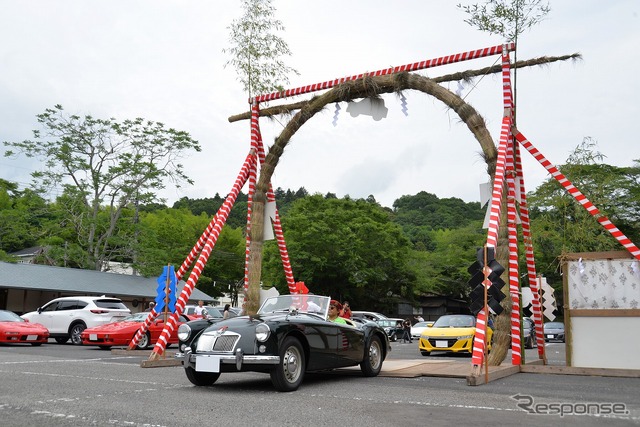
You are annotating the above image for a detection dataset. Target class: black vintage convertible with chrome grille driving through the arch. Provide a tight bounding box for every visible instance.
[176,295,391,391]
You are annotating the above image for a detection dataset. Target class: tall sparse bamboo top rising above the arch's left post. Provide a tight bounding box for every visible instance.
[222,0,298,97]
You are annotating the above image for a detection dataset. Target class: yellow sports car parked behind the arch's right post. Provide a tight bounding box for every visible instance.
[418,314,493,356]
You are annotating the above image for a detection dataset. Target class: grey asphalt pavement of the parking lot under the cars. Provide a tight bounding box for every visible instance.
[0,343,640,427]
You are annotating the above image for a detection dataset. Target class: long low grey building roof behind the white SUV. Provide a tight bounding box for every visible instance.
[0,262,215,301]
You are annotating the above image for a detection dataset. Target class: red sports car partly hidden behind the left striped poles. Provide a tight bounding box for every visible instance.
[81,312,196,350]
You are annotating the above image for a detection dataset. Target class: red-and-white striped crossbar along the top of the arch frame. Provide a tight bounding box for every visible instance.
[255,43,515,102]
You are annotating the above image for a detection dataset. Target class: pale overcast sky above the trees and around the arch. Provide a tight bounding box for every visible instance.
[0,0,640,207]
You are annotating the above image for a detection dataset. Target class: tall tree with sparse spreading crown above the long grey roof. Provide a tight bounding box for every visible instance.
[4,105,200,270]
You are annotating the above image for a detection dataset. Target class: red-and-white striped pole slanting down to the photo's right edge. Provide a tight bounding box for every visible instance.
[515,131,640,260]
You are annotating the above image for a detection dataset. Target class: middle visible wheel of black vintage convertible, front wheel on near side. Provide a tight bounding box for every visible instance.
[270,337,306,391]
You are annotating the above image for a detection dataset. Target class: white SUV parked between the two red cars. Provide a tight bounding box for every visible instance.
[22,296,131,345]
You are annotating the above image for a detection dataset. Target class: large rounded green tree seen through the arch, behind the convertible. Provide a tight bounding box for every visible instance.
[264,194,414,311]
